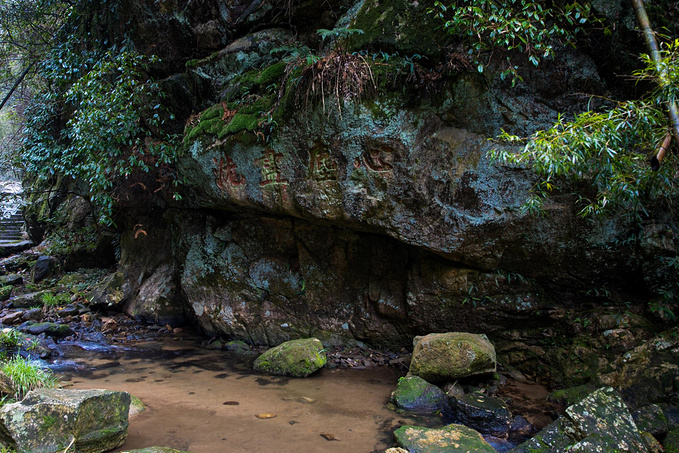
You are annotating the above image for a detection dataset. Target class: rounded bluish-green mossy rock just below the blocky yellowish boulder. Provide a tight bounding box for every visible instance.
[391,376,450,413]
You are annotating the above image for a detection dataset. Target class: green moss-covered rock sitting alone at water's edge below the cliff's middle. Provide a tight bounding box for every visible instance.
[254,338,327,377]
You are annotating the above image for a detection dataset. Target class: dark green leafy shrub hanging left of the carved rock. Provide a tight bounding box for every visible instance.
[24,44,179,224]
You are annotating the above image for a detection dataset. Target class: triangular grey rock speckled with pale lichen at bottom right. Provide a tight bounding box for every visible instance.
[510,387,650,453]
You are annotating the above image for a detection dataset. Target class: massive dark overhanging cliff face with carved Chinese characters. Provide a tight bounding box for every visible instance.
[19,0,679,388]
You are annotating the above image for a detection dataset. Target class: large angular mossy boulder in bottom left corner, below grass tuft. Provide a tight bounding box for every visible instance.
[0,389,130,453]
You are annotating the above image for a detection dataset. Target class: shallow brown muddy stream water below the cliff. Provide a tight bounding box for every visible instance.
[47,338,415,453]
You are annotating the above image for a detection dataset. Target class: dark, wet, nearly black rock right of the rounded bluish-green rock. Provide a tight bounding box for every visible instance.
[451,393,512,438]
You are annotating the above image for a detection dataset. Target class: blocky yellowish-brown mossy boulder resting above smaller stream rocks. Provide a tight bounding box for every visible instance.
[410,332,497,382]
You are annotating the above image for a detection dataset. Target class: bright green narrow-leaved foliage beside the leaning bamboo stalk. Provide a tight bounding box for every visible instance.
[491,40,679,217]
